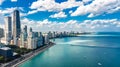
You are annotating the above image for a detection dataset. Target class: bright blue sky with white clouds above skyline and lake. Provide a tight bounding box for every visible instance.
[0,0,120,32]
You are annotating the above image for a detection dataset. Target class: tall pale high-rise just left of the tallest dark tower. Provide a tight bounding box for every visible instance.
[4,16,12,45]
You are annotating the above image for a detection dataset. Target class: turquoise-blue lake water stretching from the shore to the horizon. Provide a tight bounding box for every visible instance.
[19,32,120,67]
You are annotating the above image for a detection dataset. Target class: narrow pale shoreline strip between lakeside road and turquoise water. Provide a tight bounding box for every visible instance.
[11,44,54,67]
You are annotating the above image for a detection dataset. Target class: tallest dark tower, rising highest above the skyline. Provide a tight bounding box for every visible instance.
[12,10,21,45]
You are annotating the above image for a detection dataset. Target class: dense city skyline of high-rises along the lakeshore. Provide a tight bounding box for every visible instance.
[0,10,79,67]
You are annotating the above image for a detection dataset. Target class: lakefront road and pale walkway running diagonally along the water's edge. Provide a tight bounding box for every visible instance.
[0,42,54,67]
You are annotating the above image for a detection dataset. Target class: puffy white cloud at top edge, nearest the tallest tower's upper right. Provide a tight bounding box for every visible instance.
[30,0,83,12]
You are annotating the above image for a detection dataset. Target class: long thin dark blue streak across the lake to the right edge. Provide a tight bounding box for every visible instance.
[71,45,120,49]
